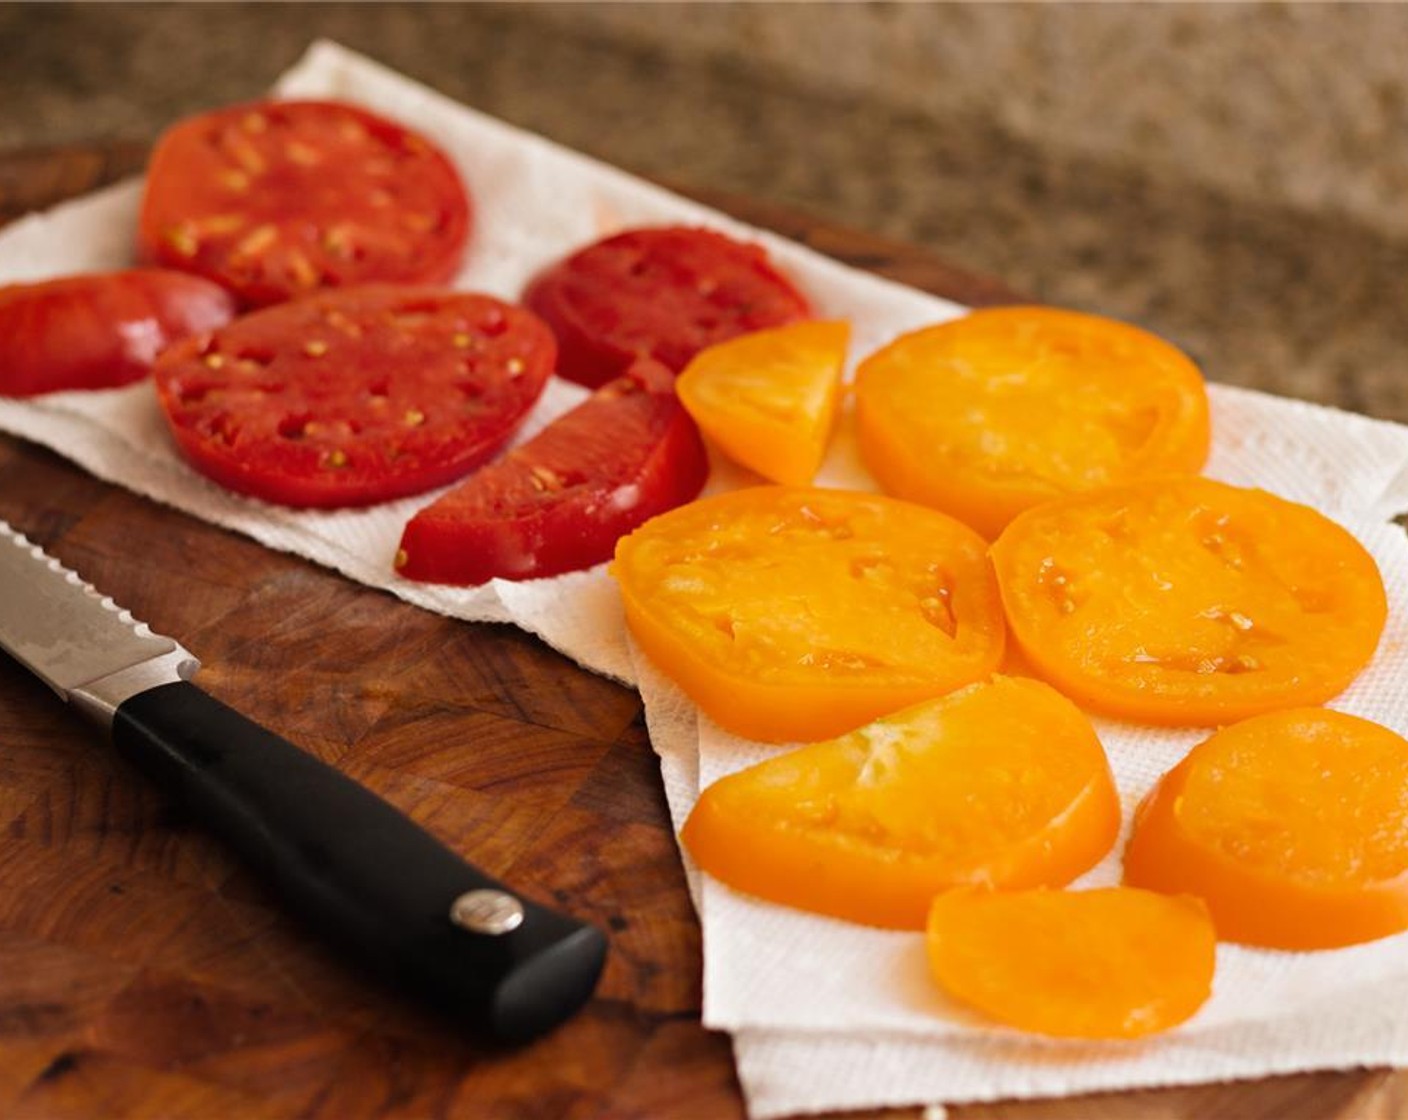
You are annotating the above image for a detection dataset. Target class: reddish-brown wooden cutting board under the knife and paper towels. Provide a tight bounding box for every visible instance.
[0,144,1408,1120]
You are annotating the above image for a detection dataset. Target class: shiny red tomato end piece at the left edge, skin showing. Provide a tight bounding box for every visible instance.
[0,269,235,397]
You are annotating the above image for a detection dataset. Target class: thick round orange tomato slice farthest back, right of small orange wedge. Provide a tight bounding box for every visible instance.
[855,307,1209,538]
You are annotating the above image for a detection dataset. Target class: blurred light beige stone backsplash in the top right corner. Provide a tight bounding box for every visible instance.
[542,3,1408,234]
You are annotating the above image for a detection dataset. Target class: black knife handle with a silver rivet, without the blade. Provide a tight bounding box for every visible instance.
[113,682,605,1043]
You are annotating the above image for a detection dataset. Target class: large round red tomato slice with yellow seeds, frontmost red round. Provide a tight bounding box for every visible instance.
[153,285,556,507]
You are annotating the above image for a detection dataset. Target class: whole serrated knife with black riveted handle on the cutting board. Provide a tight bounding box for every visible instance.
[0,520,607,1043]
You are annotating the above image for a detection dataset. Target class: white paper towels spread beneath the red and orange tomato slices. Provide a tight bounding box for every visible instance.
[8,44,1408,1117]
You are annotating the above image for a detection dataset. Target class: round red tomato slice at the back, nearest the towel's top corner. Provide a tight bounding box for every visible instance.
[138,101,470,306]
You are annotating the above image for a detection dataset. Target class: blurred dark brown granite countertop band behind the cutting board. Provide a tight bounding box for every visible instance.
[0,4,1408,421]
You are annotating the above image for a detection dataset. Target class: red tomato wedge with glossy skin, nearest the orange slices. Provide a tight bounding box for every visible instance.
[396,359,708,586]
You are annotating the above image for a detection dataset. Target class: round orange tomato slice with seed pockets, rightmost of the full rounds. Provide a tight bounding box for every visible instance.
[991,476,1387,726]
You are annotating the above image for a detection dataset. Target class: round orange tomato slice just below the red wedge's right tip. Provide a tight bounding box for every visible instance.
[611,486,1005,742]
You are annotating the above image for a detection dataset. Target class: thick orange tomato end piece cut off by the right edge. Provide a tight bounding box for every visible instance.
[1125,707,1408,950]
